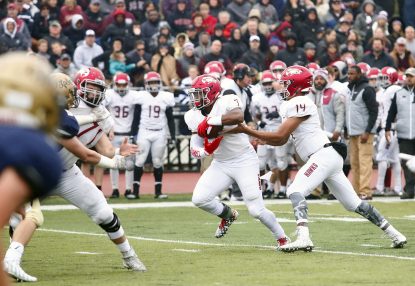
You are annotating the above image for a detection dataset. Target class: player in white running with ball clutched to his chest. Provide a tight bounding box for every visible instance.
[185,74,288,246]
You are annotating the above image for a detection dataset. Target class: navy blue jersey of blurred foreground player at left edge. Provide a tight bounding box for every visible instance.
[0,125,62,198]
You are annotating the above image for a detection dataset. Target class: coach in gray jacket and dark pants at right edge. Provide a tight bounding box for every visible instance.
[385,68,415,200]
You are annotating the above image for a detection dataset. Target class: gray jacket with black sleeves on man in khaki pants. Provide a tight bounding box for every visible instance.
[346,78,379,136]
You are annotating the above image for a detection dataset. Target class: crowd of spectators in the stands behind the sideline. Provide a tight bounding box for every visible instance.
[0,0,415,89]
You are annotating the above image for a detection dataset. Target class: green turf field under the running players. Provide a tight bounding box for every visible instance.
[3,195,415,286]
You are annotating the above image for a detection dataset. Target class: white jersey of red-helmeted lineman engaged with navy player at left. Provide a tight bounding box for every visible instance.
[59,100,112,170]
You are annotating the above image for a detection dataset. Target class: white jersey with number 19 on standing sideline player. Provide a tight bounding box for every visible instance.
[134,90,175,130]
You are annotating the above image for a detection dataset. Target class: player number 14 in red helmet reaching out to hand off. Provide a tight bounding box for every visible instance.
[232,66,407,252]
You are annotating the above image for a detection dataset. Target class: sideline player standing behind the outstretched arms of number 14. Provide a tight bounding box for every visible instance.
[252,70,289,199]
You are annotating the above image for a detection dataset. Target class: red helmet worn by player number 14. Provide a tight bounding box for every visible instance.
[280,65,313,100]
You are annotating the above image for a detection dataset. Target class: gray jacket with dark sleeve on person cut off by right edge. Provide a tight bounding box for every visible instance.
[385,86,415,139]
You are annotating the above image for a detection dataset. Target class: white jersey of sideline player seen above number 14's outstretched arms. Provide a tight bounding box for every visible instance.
[251,91,283,131]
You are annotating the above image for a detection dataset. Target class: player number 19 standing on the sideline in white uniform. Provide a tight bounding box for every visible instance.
[130,72,176,199]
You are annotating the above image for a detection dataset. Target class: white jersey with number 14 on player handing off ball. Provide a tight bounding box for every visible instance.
[281,96,330,162]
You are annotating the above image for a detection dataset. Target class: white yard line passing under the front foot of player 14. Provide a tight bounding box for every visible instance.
[38,228,415,261]
